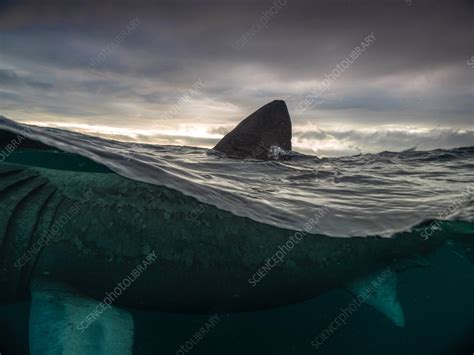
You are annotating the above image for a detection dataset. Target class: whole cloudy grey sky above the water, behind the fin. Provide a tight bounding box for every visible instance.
[0,0,474,156]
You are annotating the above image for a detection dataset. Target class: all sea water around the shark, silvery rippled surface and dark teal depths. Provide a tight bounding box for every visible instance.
[0,119,474,355]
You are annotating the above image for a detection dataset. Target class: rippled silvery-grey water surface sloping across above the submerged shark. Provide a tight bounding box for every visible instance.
[0,117,474,237]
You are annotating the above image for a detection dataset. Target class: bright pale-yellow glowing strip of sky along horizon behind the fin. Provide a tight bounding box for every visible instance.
[12,120,474,156]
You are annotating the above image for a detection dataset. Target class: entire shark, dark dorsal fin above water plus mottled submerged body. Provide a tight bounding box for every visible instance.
[0,101,472,354]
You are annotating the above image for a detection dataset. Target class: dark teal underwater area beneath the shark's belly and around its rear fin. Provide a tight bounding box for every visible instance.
[0,246,474,355]
